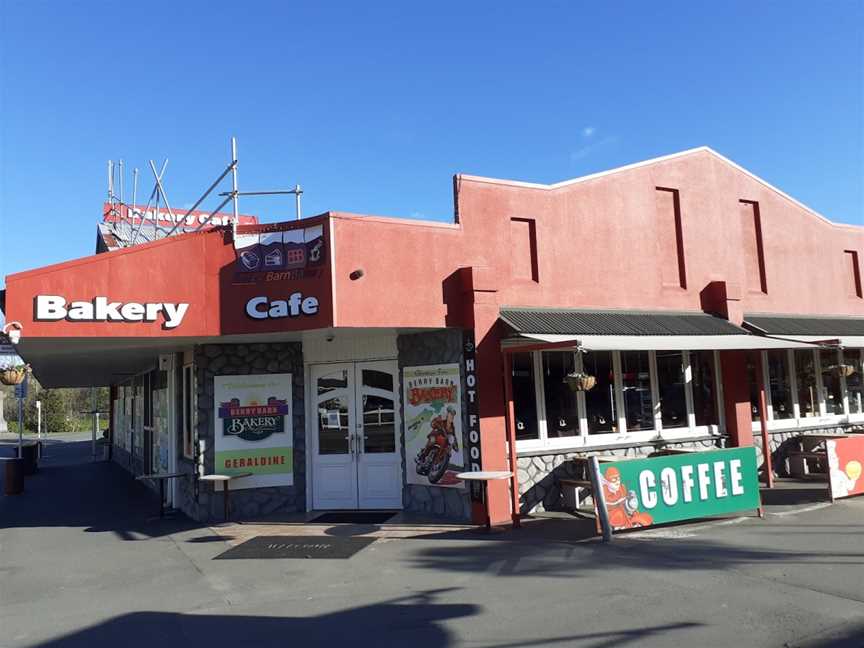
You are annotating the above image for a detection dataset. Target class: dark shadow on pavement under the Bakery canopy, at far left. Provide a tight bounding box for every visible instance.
[0,441,207,540]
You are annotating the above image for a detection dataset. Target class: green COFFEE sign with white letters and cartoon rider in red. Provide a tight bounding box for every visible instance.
[600,448,761,531]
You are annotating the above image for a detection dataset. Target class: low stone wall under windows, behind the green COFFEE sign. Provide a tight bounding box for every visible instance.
[516,437,725,515]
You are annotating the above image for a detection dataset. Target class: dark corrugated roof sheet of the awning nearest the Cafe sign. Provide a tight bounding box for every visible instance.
[500,306,747,335]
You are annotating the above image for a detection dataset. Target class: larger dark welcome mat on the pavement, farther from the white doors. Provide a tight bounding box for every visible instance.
[214,536,375,560]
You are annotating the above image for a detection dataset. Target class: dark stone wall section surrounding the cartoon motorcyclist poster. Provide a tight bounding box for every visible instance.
[396,329,471,521]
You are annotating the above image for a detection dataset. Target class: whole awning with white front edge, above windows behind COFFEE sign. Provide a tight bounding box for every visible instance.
[500,307,814,351]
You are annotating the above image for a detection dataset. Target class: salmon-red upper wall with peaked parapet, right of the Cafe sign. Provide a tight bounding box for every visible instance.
[333,150,864,326]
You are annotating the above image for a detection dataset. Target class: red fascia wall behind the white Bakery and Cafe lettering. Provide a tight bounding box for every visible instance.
[6,218,333,338]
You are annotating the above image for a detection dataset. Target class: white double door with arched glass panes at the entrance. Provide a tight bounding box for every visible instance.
[310,361,402,510]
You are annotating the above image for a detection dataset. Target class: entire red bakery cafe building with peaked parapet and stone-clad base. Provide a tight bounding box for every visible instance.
[3,148,864,522]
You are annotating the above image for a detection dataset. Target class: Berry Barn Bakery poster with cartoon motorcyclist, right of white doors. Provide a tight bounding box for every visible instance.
[402,363,465,488]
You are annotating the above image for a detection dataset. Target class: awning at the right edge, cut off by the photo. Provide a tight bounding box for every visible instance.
[744,313,864,348]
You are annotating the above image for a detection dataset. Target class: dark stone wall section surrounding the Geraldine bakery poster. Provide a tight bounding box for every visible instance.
[171,342,306,522]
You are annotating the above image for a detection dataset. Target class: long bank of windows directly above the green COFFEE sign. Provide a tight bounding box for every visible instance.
[511,350,720,449]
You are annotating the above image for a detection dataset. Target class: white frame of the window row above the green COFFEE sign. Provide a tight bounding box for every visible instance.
[516,349,725,453]
